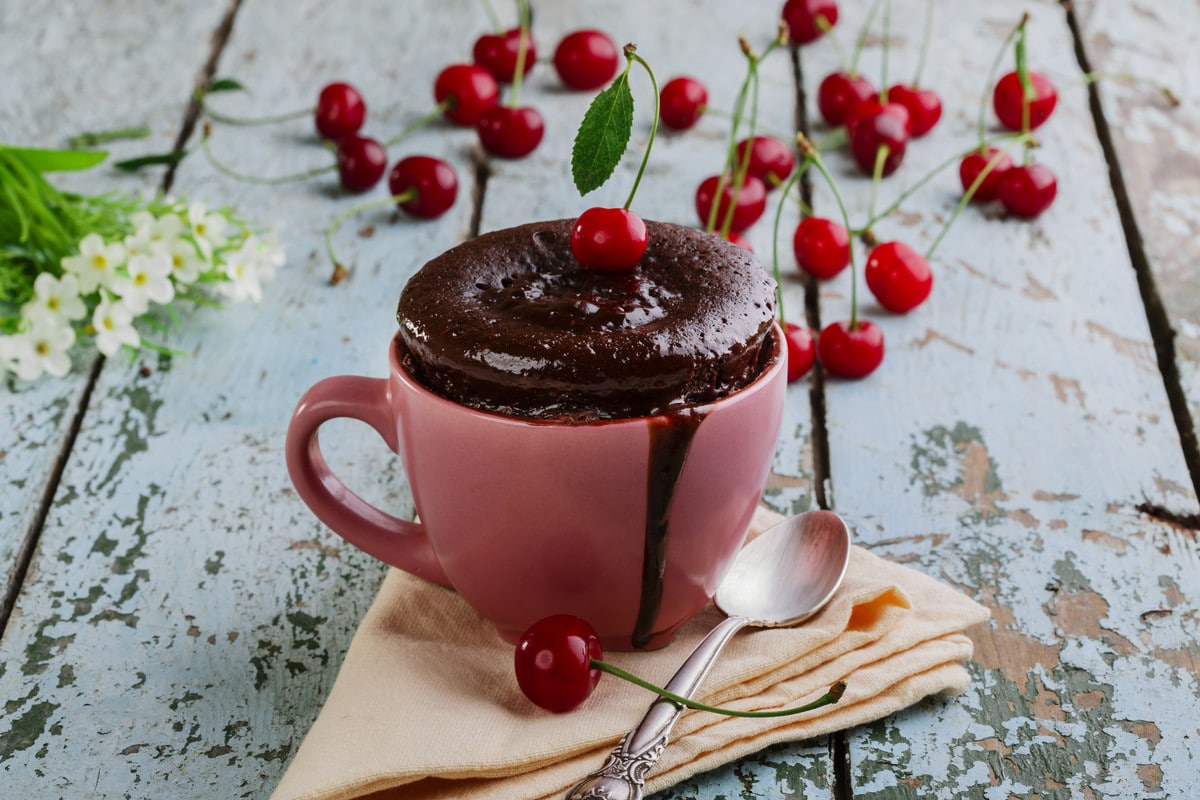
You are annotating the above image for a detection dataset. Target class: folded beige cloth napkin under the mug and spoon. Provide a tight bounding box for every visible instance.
[271,510,988,800]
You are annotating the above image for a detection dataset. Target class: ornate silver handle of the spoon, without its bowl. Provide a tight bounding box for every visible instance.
[566,616,750,800]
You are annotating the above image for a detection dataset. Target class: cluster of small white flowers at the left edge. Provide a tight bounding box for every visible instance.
[0,200,283,380]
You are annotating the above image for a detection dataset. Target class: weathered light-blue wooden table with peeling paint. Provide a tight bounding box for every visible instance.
[0,0,1200,799]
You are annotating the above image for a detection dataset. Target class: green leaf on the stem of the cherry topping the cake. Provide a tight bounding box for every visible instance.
[571,71,634,194]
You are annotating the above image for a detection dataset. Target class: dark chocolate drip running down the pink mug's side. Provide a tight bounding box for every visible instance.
[632,408,704,648]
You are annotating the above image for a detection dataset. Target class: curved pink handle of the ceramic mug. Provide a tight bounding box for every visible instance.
[286,375,450,587]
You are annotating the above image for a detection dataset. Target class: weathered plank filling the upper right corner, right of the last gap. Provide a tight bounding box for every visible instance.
[1073,1,1200,494]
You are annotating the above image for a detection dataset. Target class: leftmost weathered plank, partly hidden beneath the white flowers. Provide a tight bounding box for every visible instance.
[0,0,222,609]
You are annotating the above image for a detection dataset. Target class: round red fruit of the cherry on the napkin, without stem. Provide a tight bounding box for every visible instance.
[512,614,604,714]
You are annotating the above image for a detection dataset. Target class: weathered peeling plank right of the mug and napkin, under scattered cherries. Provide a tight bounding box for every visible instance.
[787,2,1200,798]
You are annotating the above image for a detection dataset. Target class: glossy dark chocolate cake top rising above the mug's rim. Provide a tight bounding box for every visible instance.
[397,219,775,421]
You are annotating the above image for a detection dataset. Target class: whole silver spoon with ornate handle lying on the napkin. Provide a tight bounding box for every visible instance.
[566,511,850,800]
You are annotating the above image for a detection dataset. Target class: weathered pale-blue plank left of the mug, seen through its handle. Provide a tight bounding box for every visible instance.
[0,1,485,798]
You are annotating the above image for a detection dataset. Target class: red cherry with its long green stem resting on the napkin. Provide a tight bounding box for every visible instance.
[514,614,846,717]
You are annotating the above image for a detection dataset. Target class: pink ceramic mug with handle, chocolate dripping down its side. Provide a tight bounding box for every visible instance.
[287,325,787,649]
